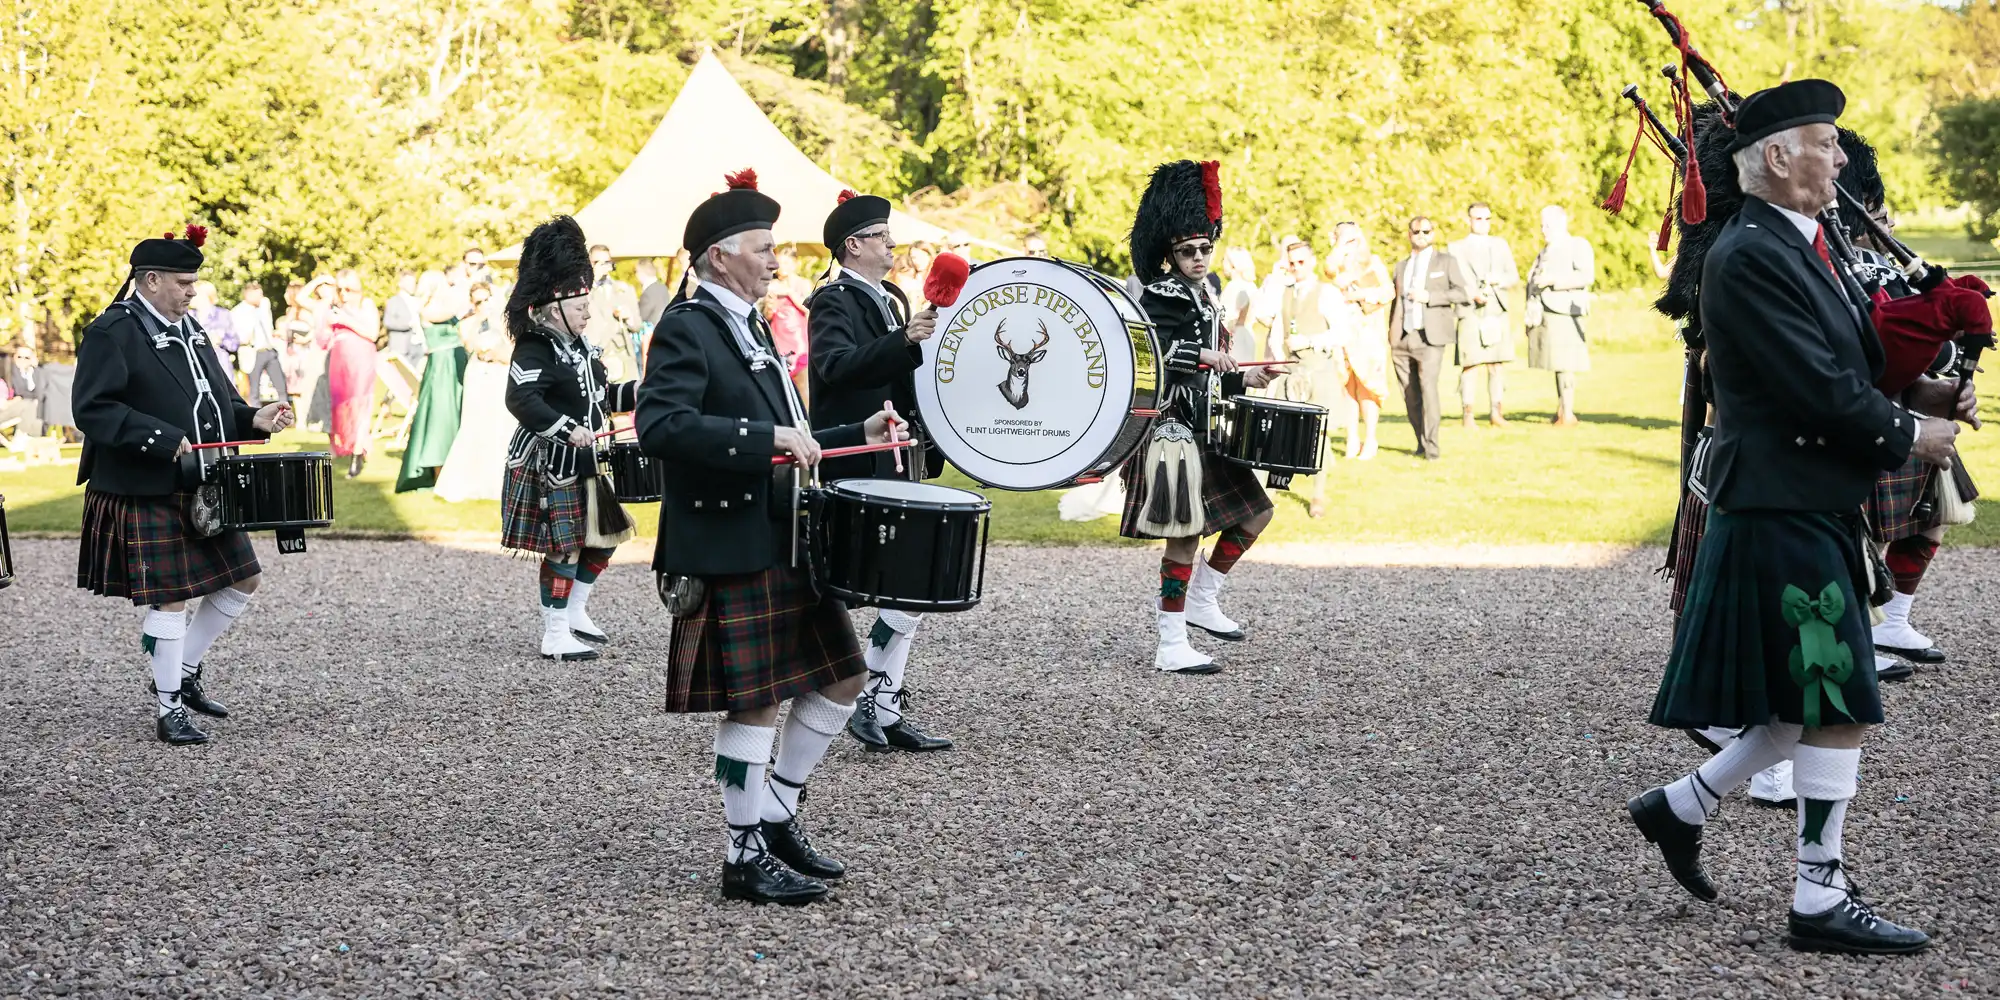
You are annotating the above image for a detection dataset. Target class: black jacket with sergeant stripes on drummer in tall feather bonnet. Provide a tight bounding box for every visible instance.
[506,328,638,486]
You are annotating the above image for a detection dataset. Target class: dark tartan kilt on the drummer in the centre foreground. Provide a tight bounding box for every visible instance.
[666,566,866,714]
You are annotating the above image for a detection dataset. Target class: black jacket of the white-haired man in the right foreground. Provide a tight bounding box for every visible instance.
[1700,198,1916,512]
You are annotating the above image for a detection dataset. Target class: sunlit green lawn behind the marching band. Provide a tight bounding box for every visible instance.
[11,292,2000,546]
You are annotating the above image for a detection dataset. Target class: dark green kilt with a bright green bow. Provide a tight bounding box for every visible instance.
[1652,508,1882,730]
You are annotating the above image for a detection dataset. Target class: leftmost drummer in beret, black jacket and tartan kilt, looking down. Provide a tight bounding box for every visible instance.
[74,226,292,746]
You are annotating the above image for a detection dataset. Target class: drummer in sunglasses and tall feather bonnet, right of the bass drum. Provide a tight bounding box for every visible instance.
[1118,160,1282,674]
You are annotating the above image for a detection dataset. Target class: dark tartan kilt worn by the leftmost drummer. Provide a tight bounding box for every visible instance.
[76,490,262,604]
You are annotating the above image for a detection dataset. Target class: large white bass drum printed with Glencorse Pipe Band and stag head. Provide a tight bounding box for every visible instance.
[916,258,1160,490]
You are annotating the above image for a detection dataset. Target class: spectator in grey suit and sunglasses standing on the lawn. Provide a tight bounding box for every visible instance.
[1388,216,1472,462]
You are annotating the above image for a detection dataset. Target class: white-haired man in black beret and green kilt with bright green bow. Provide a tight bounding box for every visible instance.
[1626,80,1974,954]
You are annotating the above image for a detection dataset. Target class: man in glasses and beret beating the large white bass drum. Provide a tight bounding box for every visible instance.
[806,192,952,752]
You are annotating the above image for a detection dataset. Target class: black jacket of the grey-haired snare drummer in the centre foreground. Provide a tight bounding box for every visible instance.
[638,292,864,576]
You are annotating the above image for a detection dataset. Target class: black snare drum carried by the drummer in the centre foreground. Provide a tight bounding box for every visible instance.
[814,480,992,612]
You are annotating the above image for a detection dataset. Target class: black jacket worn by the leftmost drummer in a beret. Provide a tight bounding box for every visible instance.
[72,300,270,496]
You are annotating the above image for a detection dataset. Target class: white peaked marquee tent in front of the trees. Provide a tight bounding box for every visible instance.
[494,52,946,260]
